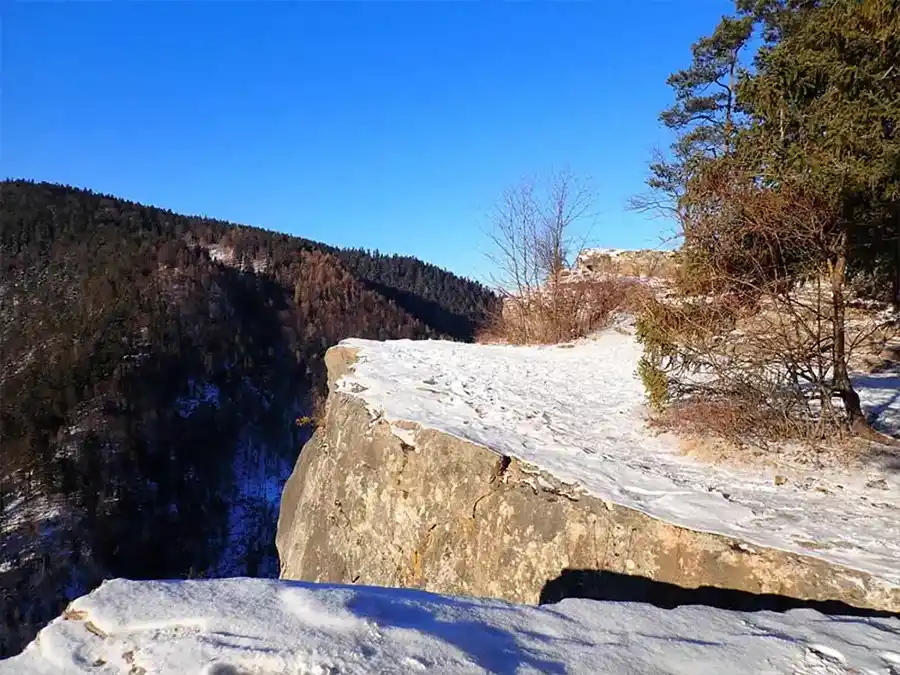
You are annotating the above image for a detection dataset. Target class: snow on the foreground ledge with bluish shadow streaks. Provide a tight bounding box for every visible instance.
[0,579,900,675]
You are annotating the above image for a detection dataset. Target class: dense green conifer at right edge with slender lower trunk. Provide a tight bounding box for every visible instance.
[739,0,900,428]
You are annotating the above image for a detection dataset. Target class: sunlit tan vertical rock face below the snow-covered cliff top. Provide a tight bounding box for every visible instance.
[277,346,900,612]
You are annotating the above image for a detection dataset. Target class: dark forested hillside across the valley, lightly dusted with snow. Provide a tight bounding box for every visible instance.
[0,181,496,657]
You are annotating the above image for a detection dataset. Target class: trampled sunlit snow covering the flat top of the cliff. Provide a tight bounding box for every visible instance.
[338,329,900,585]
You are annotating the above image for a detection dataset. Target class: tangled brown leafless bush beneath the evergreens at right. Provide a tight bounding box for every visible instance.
[637,172,896,442]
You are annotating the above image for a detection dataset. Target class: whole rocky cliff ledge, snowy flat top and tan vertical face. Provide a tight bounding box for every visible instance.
[277,329,900,612]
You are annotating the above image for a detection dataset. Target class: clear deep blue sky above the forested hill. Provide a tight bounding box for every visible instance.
[0,0,731,276]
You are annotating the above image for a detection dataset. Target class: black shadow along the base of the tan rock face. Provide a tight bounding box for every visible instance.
[539,569,898,617]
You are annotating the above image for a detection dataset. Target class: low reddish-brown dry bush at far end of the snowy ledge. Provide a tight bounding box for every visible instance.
[478,277,648,344]
